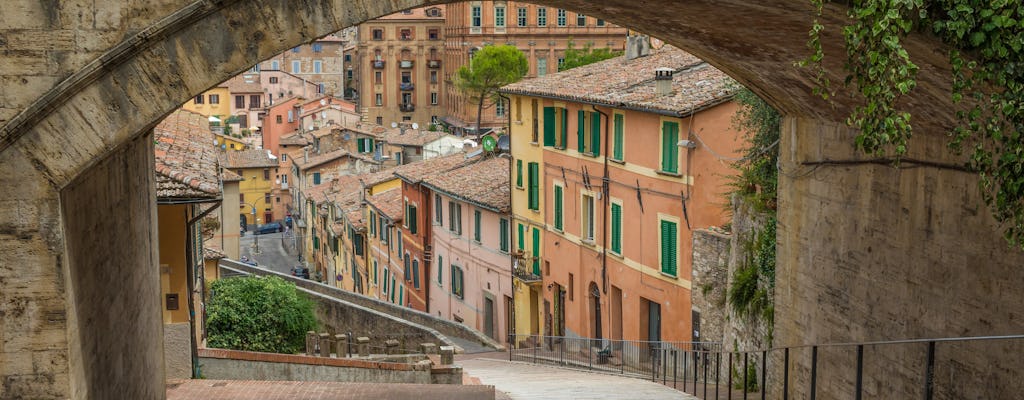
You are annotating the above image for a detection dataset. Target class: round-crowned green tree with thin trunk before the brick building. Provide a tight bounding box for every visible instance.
[455,45,529,135]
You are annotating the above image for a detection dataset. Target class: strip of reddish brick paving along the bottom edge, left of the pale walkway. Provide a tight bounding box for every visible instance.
[167,380,495,400]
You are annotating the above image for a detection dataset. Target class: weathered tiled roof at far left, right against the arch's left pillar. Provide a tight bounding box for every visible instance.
[153,109,220,198]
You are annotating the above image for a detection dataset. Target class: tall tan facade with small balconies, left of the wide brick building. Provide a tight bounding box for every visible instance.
[355,5,446,128]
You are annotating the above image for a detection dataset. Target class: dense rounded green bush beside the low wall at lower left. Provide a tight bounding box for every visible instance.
[207,276,316,354]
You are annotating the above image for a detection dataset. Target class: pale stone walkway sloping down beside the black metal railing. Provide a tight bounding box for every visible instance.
[456,358,697,400]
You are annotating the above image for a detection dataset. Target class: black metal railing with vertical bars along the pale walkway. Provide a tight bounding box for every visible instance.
[509,335,1024,400]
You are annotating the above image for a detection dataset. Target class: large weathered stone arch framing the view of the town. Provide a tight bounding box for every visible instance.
[0,0,1024,398]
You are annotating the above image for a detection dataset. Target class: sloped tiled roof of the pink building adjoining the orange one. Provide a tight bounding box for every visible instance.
[423,157,511,213]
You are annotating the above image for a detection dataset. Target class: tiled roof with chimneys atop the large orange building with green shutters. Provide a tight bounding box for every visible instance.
[501,46,734,116]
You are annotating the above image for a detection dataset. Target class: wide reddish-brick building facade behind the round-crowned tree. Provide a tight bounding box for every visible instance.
[443,1,627,133]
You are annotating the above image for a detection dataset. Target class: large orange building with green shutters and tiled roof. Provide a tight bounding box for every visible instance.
[503,42,742,342]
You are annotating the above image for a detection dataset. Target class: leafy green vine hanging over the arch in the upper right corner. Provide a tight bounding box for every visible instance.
[799,0,1024,248]
